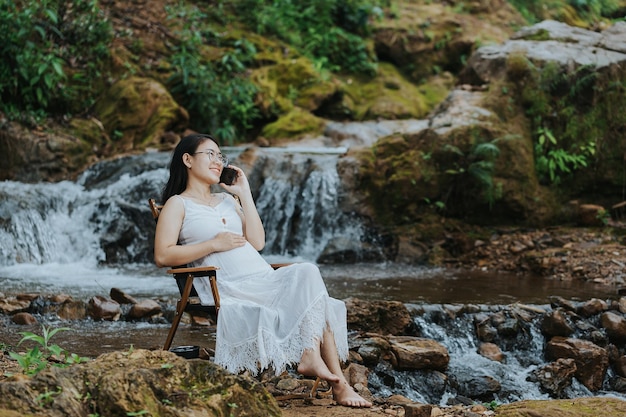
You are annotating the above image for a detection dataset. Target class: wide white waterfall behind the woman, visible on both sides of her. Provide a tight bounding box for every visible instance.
[0,148,362,294]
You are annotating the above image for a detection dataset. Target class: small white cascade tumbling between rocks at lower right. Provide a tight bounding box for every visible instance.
[369,305,626,405]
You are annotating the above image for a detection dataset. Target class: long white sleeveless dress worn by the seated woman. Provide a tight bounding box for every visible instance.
[176,193,348,375]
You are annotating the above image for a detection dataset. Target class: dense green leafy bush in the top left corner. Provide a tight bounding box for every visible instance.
[0,0,113,118]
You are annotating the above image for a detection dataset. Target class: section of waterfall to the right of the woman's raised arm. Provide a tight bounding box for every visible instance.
[249,148,364,261]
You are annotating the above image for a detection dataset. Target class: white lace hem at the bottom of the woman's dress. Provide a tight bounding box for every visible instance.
[215,295,348,375]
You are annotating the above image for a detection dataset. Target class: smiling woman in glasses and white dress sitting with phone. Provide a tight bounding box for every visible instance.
[154,134,371,407]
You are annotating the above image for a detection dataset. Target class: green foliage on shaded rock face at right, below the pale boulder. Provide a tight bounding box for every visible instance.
[522,64,612,184]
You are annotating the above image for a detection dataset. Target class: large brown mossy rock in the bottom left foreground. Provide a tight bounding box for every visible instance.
[0,349,281,417]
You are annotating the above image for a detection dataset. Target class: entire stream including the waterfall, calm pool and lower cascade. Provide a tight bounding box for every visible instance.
[0,145,621,403]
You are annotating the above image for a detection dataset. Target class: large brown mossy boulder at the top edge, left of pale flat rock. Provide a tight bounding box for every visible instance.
[372,0,525,83]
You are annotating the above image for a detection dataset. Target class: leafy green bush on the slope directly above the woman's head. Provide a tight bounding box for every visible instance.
[167,4,260,144]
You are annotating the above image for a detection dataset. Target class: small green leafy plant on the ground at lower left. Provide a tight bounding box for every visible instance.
[9,326,89,375]
